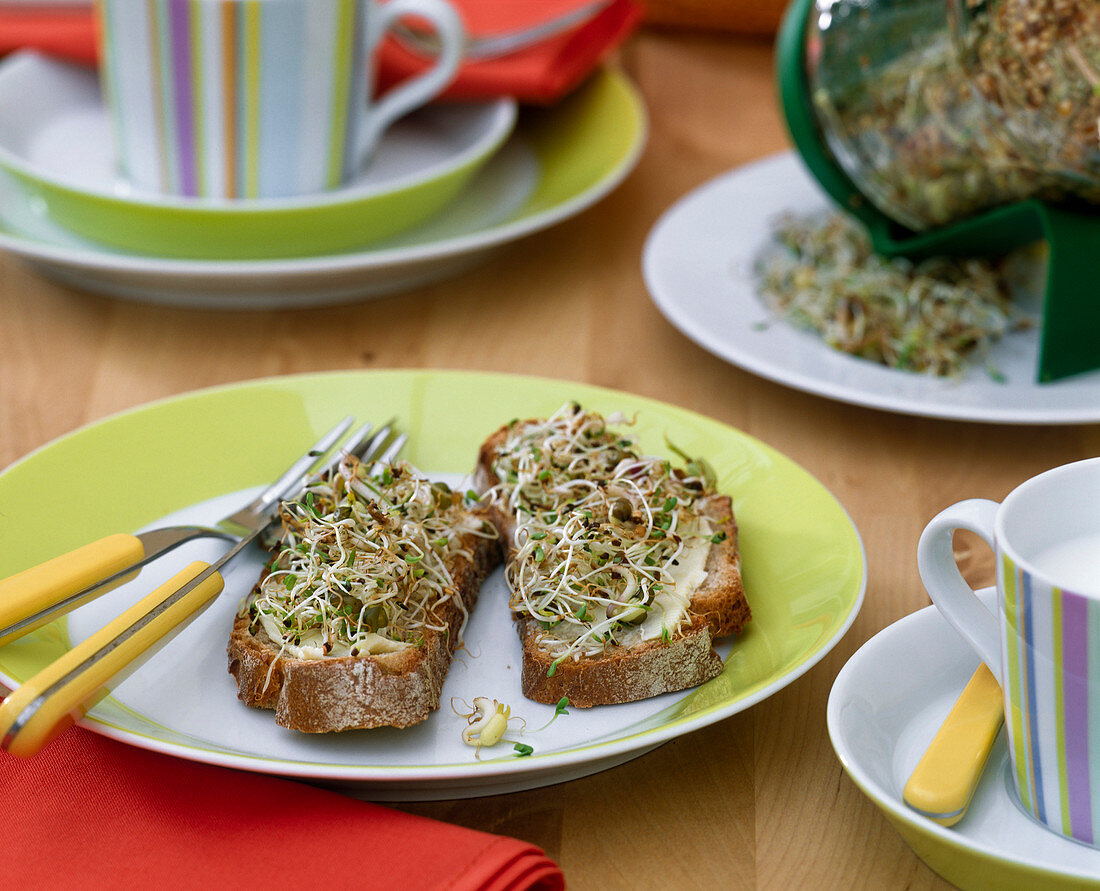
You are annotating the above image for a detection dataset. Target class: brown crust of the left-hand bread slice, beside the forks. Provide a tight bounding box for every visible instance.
[228,521,501,733]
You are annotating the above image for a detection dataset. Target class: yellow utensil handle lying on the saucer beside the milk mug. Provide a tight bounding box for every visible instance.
[902,662,1004,826]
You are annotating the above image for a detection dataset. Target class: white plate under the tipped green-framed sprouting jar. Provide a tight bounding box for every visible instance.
[642,154,1100,424]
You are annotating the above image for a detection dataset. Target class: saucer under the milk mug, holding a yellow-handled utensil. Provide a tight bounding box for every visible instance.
[828,589,1100,889]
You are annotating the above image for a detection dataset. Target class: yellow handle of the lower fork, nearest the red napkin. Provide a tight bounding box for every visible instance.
[0,560,224,757]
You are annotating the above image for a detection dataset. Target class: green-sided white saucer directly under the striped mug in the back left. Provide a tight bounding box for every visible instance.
[0,52,517,260]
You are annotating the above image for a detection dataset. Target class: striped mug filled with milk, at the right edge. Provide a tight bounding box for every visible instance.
[917,459,1100,845]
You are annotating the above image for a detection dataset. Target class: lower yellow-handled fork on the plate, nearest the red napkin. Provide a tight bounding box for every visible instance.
[0,426,406,757]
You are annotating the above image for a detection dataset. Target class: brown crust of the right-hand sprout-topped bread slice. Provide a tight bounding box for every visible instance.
[474,413,752,708]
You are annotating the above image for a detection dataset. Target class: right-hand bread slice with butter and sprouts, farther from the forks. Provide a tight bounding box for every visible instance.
[474,405,751,707]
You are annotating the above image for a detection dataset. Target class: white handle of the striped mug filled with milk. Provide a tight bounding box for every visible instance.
[916,498,1001,682]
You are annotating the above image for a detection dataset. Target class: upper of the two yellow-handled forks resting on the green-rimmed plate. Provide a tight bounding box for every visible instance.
[0,417,388,647]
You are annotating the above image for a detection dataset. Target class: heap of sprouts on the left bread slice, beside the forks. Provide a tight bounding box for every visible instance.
[241,457,496,659]
